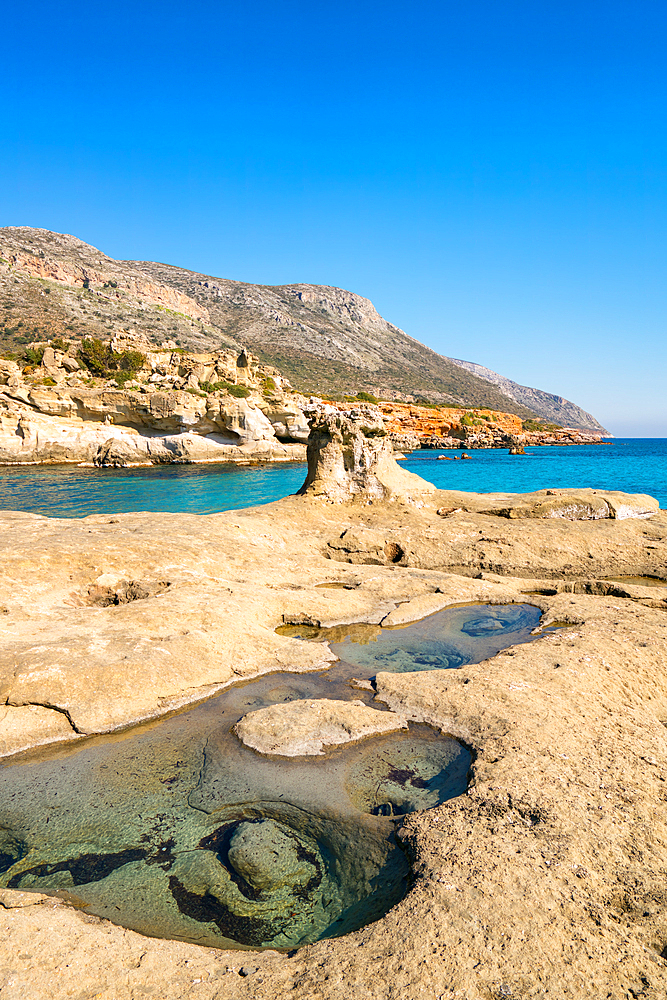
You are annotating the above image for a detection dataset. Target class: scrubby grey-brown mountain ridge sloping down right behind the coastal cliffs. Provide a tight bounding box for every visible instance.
[0,226,600,428]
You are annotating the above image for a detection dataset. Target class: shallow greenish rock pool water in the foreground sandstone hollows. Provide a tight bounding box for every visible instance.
[0,605,540,949]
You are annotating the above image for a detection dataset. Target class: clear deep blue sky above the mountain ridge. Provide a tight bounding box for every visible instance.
[0,0,667,437]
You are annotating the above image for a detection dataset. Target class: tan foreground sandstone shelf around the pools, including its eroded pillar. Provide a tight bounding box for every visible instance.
[0,407,667,1000]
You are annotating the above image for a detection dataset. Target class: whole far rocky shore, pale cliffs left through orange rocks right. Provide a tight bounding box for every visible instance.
[0,335,601,466]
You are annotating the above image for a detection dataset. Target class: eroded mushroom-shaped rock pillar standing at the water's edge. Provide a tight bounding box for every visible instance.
[300,404,435,503]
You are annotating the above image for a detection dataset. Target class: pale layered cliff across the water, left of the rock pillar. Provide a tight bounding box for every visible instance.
[0,335,309,465]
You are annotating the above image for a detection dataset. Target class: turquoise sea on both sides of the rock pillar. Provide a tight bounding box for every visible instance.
[0,438,667,517]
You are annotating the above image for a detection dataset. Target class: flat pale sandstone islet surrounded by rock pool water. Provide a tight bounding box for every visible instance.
[234,698,407,757]
